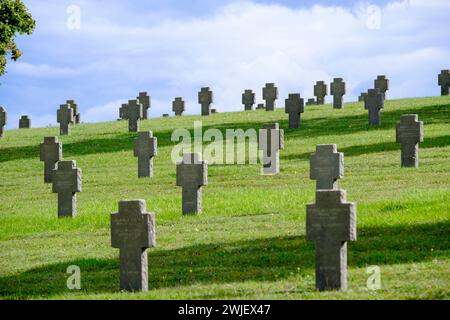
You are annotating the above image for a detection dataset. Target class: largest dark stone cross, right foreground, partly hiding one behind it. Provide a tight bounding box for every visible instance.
[306,190,356,291]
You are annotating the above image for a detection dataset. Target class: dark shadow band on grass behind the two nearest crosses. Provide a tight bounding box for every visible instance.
[0,222,450,299]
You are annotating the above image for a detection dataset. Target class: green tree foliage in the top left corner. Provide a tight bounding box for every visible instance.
[0,0,36,76]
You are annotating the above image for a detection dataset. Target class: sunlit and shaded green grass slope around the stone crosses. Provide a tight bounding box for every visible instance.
[0,97,450,299]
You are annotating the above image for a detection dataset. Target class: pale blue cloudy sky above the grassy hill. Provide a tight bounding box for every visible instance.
[0,0,450,128]
